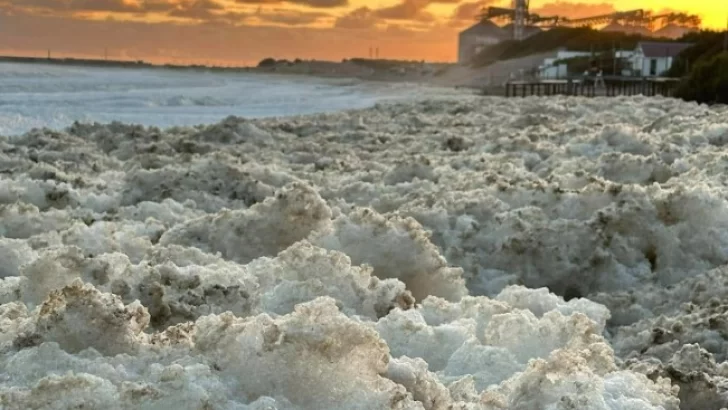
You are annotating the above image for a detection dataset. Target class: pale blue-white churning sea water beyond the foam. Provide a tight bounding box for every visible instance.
[0,63,450,135]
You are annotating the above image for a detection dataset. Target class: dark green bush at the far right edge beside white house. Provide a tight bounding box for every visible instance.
[675,52,728,104]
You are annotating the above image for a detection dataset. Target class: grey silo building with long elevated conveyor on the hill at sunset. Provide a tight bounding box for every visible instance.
[458,0,701,63]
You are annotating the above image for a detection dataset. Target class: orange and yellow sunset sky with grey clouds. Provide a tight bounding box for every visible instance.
[0,0,728,65]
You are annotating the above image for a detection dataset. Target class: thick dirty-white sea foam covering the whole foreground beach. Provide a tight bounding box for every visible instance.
[0,96,728,410]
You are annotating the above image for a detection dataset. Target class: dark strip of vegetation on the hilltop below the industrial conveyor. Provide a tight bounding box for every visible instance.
[473,27,647,67]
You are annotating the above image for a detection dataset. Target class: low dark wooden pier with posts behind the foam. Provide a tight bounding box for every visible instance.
[505,77,679,97]
